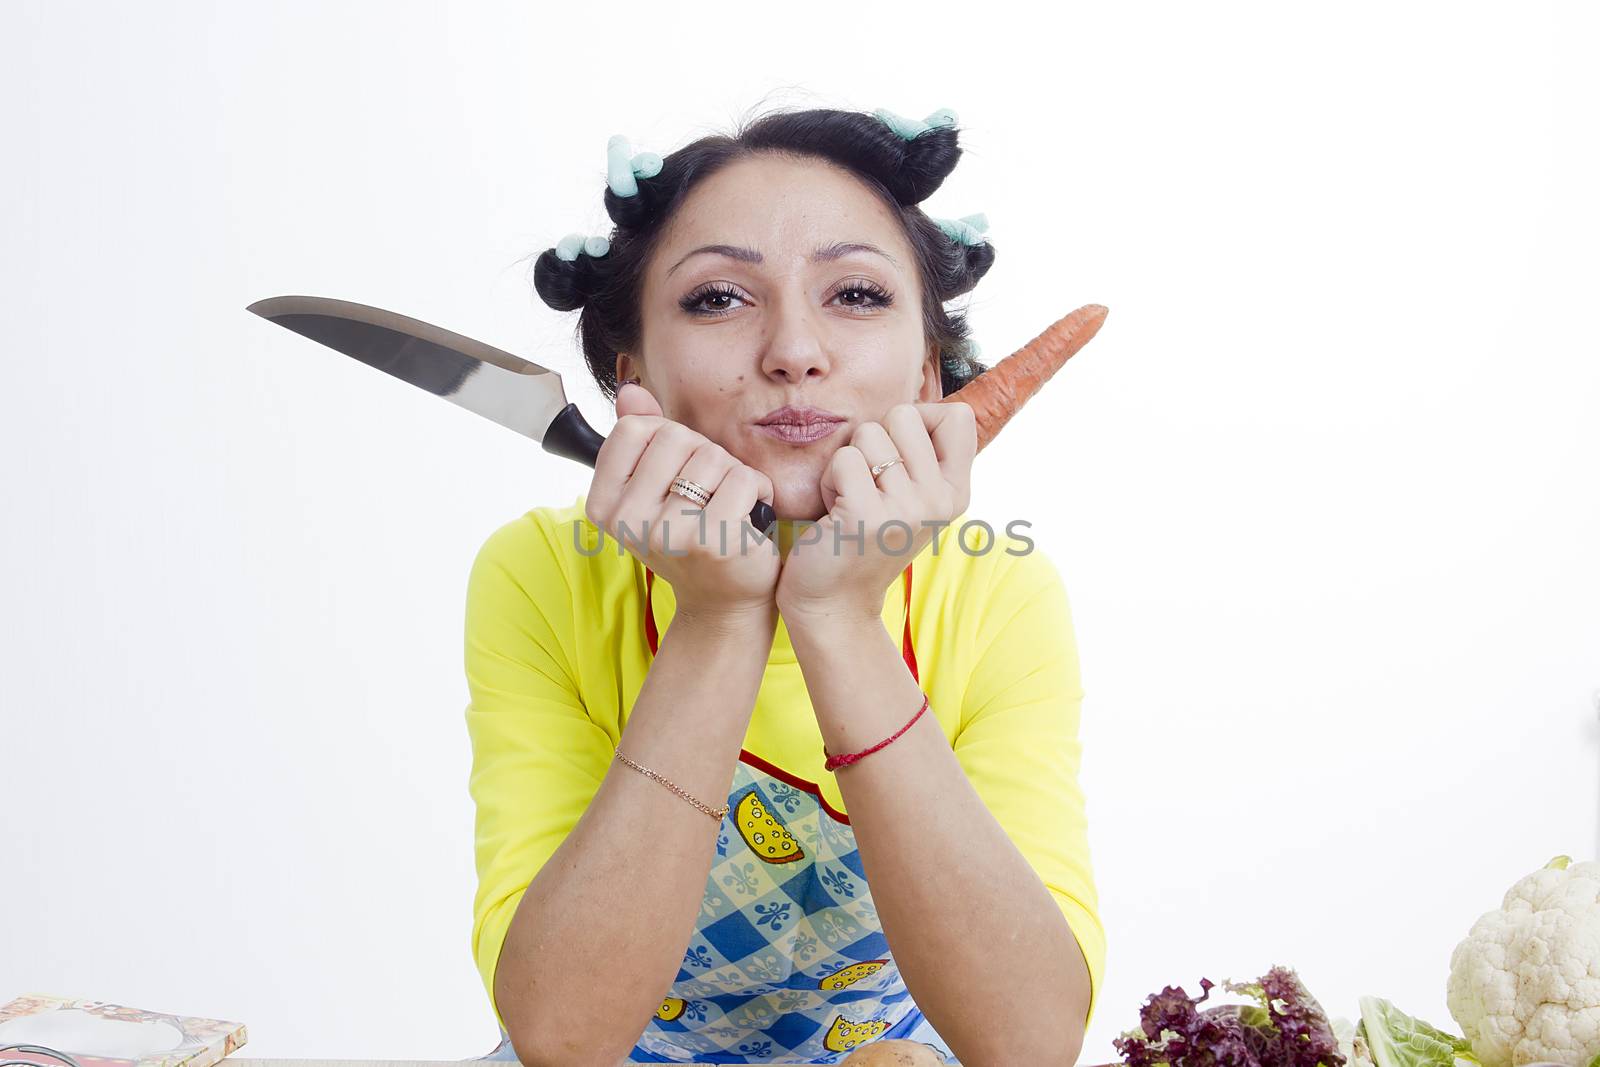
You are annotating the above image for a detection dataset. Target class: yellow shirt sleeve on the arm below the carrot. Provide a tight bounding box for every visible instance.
[952,545,1106,1025]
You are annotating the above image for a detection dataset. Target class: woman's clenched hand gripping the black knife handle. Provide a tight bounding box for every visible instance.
[584,382,782,619]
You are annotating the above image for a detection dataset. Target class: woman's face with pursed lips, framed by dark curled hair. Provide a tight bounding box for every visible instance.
[618,155,941,520]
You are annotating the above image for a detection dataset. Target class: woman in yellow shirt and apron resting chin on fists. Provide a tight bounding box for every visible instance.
[466,109,1106,1065]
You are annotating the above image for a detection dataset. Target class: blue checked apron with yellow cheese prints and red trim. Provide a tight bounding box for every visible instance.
[483,565,955,1064]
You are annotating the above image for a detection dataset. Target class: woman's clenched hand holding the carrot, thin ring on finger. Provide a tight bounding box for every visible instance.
[778,403,978,625]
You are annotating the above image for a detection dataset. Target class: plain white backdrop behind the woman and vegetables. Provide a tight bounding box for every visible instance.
[0,0,1600,1062]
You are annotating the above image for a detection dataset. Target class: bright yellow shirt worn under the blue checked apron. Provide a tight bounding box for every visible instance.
[466,496,1106,1043]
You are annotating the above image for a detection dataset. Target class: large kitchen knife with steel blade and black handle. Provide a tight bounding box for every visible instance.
[246,296,778,536]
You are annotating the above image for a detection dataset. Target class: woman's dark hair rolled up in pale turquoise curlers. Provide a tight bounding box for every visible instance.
[533,107,995,398]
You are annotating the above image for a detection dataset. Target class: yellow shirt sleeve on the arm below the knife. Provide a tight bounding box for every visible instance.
[466,514,614,1027]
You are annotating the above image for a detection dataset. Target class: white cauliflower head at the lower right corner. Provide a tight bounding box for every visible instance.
[1445,856,1600,1067]
